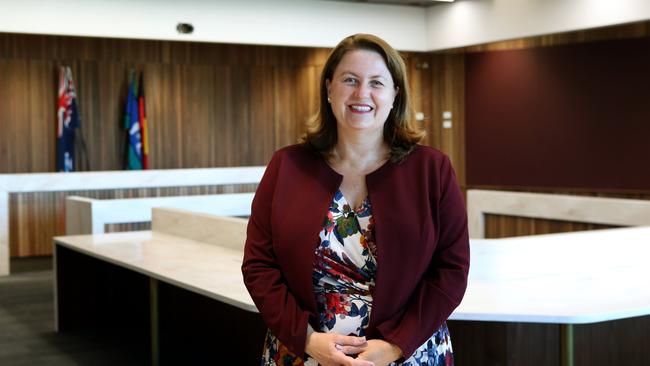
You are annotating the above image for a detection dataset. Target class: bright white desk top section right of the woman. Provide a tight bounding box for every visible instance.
[450,227,650,324]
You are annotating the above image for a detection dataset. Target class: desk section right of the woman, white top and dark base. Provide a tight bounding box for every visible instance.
[450,227,650,366]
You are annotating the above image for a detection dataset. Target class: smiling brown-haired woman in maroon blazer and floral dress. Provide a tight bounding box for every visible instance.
[242,34,469,366]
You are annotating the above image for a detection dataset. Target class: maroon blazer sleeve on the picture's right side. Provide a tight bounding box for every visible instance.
[377,156,469,359]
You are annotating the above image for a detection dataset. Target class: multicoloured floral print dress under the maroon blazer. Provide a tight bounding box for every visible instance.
[261,190,454,366]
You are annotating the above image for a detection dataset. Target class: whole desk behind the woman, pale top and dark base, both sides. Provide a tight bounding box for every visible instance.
[54,213,650,365]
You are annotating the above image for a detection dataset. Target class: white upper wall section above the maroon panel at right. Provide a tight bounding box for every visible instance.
[426,0,650,50]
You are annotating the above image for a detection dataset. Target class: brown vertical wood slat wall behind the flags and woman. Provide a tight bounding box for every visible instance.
[0,23,650,255]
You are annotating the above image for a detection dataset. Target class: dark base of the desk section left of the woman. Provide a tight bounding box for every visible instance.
[56,246,266,365]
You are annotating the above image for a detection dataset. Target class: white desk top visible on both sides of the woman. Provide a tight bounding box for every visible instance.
[55,227,650,324]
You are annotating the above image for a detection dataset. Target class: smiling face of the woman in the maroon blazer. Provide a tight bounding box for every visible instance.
[326,50,398,134]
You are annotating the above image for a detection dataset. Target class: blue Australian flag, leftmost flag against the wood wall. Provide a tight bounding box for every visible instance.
[56,67,80,172]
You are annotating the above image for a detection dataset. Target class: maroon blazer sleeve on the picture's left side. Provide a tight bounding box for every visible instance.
[242,151,309,358]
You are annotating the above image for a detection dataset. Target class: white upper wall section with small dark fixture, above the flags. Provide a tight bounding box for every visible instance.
[0,0,426,51]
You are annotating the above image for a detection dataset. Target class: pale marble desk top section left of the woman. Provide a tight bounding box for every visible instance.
[54,231,257,312]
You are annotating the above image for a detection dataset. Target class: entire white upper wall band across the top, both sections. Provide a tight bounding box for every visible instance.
[0,0,650,51]
